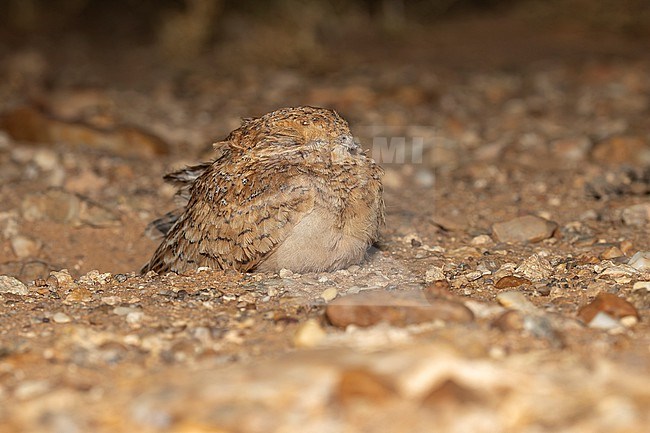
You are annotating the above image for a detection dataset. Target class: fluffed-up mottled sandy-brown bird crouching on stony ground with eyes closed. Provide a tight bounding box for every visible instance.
[141,106,384,274]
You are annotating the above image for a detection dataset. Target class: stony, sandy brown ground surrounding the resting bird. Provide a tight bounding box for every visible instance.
[0,6,650,433]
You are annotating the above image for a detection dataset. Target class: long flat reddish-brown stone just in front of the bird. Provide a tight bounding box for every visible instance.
[325,290,474,328]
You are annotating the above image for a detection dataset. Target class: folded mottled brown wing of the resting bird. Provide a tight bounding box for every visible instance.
[143,161,316,272]
